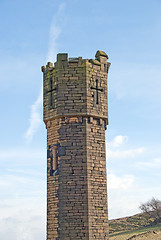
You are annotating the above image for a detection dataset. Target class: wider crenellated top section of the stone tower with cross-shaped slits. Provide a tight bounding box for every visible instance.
[42,51,110,122]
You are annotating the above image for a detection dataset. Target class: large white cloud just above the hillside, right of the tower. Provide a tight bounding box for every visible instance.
[107,183,160,219]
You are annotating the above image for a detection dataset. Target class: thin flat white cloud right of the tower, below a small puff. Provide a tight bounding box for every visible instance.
[107,147,145,159]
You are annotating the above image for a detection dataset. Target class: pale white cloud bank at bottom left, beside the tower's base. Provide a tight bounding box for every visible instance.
[0,198,46,240]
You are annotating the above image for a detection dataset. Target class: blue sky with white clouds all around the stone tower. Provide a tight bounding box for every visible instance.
[0,0,161,240]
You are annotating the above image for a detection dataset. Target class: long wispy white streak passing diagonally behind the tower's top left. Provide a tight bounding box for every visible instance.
[25,3,65,142]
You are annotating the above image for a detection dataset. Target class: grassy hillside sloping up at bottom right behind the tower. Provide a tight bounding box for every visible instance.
[109,214,161,240]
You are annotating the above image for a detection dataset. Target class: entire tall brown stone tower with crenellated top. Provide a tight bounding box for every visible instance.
[42,51,110,240]
